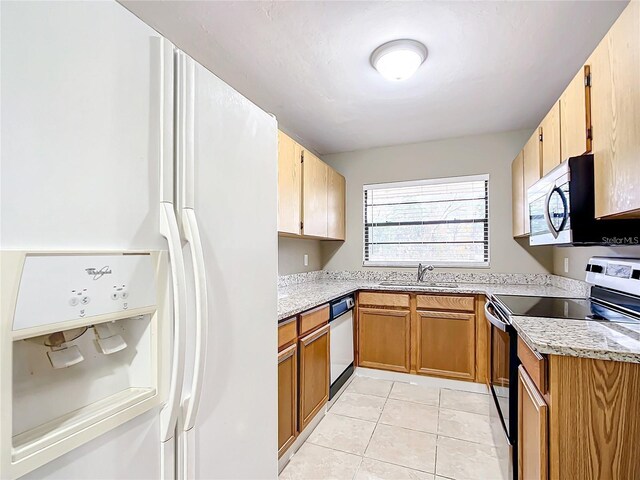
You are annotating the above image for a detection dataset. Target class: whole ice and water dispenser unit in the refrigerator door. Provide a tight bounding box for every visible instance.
[0,251,170,479]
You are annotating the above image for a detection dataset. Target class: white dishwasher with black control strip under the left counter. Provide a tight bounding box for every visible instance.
[329,295,355,400]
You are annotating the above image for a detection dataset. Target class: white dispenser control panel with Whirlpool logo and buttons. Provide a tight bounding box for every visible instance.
[13,253,157,330]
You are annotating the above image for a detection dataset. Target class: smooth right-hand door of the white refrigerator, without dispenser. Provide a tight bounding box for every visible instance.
[181,55,278,479]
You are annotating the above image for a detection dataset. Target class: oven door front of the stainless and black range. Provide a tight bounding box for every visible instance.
[485,300,519,479]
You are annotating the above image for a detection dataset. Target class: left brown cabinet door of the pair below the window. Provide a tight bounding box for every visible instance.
[358,308,411,373]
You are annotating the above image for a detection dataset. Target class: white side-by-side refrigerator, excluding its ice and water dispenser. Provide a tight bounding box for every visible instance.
[0,2,277,479]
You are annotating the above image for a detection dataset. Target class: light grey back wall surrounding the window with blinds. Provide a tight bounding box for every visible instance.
[322,130,553,273]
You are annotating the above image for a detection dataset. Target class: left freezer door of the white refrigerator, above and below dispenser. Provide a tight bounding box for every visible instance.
[0,2,172,479]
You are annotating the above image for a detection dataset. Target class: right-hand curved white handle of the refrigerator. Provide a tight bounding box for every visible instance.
[182,208,209,431]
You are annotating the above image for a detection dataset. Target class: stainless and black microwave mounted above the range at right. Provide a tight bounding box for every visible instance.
[527,155,640,245]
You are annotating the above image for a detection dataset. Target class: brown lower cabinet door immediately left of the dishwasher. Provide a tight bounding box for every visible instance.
[299,325,329,431]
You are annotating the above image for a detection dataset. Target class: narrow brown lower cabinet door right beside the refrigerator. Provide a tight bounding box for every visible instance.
[278,344,298,457]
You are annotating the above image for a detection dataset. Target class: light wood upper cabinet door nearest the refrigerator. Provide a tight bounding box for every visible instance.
[278,131,302,235]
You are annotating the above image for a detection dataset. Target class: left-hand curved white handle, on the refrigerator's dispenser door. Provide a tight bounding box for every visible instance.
[160,202,187,442]
